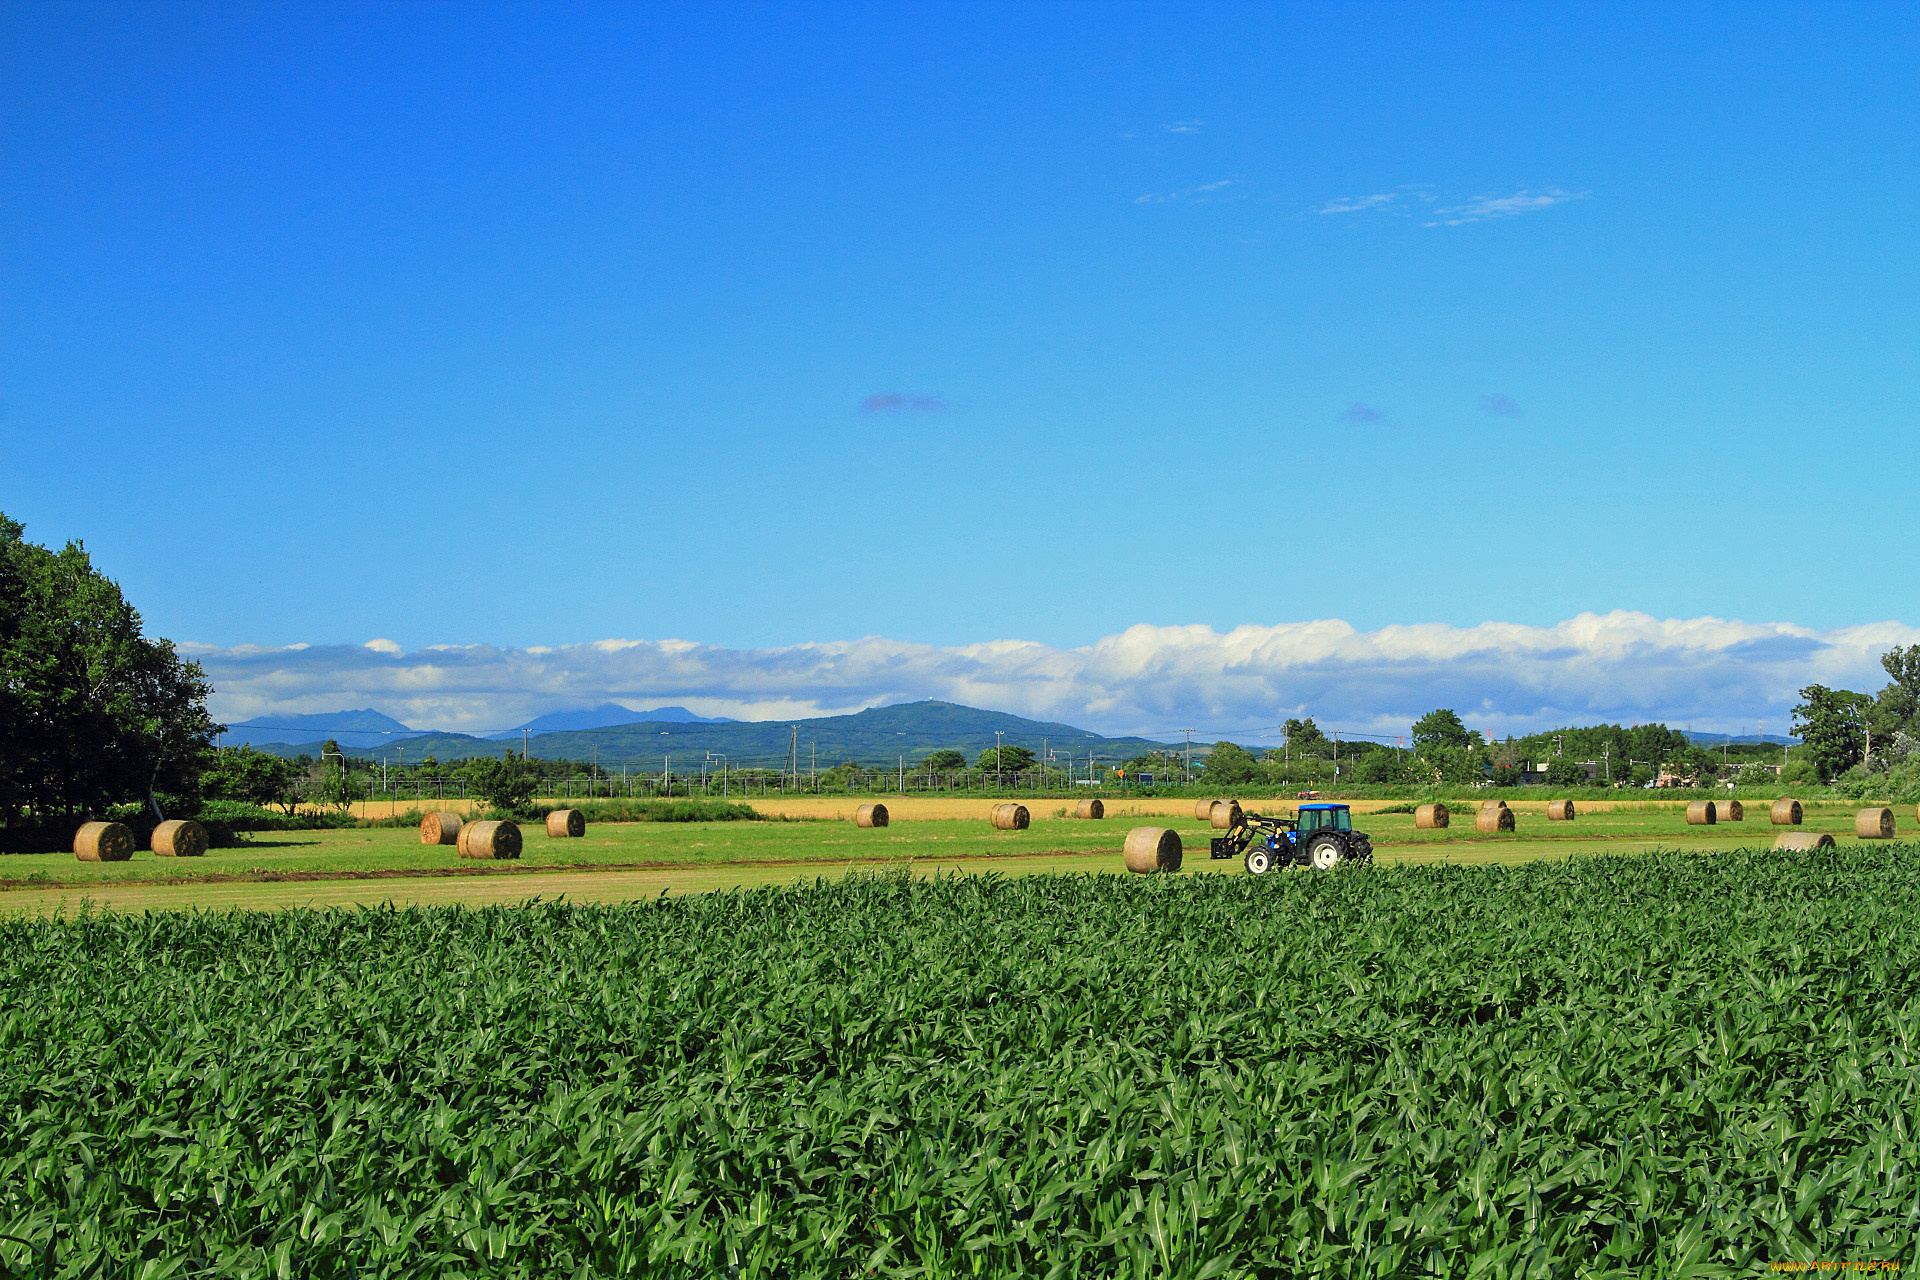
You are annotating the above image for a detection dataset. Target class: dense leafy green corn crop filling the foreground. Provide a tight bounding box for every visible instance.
[0,846,1920,1280]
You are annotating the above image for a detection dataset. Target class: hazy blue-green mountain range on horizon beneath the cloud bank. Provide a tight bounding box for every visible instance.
[227,700,1175,773]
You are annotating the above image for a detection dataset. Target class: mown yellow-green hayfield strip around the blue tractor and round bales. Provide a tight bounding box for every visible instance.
[0,798,1889,913]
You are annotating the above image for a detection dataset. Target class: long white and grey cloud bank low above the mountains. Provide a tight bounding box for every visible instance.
[180,612,1920,743]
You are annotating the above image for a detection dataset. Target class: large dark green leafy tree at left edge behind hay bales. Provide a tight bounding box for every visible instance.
[0,514,221,821]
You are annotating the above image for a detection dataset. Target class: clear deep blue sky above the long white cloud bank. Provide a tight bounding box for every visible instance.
[0,4,1920,727]
